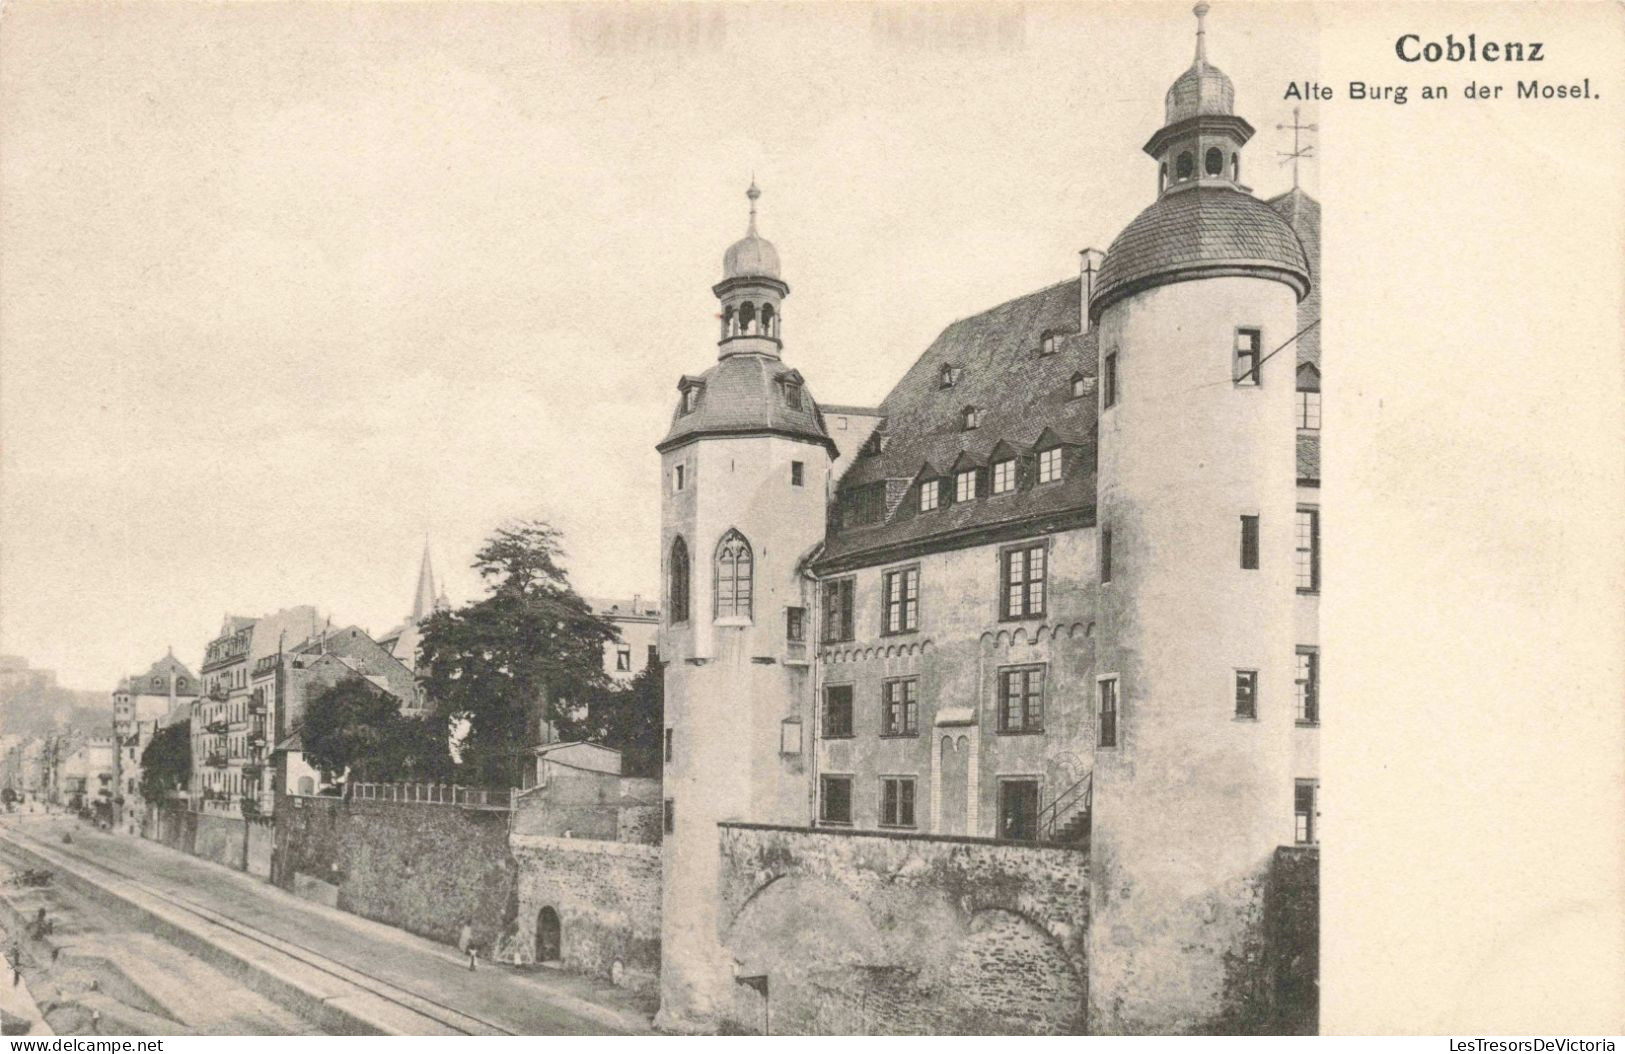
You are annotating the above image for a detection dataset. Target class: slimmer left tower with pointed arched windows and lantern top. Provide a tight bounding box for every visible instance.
[657,184,835,1031]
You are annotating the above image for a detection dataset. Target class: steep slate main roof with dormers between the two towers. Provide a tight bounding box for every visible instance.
[817,279,1097,567]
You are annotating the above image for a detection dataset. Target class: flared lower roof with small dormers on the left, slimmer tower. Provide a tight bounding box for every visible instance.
[658,354,834,450]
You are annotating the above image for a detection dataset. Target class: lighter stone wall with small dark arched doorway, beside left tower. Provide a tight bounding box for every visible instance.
[510,835,660,991]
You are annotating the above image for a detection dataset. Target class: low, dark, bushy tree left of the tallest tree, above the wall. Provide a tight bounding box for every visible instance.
[301,677,450,783]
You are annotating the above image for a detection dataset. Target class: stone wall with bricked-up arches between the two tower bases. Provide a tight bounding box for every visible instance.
[718,823,1089,1035]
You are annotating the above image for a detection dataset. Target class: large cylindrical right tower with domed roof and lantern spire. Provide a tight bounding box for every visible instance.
[1089,3,1308,1033]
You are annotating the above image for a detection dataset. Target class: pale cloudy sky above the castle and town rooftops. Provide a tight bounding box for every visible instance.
[0,0,1316,690]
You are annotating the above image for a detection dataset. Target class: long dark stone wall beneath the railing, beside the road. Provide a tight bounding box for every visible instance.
[271,796,517,953]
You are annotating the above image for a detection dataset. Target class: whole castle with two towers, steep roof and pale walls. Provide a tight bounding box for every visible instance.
[658,5,1320,1033]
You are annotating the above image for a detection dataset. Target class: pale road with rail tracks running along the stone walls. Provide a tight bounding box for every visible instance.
[0,815,652,1035]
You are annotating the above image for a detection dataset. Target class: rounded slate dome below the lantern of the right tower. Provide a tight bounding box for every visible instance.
[1089,185,1310,317]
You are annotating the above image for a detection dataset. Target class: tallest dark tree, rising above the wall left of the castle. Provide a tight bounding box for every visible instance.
[418,521,621,786]
